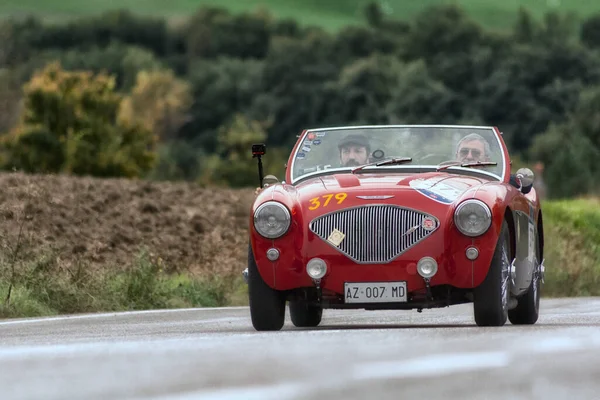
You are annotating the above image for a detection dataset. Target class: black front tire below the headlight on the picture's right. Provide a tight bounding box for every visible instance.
[473,221,511,326]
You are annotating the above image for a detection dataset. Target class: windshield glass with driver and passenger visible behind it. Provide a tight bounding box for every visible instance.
[291,126,506,182]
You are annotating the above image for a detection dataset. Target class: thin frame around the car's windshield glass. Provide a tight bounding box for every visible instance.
[286,124,510,185]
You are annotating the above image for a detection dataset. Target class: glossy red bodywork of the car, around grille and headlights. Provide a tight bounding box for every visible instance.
[249,129,540,306]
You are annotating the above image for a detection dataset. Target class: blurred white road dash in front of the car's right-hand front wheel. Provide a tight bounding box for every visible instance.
[353,351,510,379]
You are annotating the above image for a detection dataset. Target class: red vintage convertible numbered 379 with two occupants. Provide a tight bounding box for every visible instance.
[244,125,544,331]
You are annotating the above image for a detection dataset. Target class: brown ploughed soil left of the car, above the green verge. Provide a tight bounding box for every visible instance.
[0,173,254,274]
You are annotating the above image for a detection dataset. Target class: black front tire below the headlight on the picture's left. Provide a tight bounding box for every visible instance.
[248,246,286,331]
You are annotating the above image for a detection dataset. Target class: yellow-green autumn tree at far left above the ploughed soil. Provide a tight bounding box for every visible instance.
[2,63,156,177]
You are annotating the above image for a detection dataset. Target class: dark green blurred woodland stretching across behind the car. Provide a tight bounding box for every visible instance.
[0,2,600,197]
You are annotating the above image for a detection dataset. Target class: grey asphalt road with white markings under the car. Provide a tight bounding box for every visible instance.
[0,298,600,400]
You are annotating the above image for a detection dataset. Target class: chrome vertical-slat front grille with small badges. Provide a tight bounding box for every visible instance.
[309,204,439,264]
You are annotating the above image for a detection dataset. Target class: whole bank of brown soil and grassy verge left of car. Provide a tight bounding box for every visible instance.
[0,173,254,316]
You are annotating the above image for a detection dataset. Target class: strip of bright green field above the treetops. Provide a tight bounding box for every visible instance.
[0,0,600,30]
